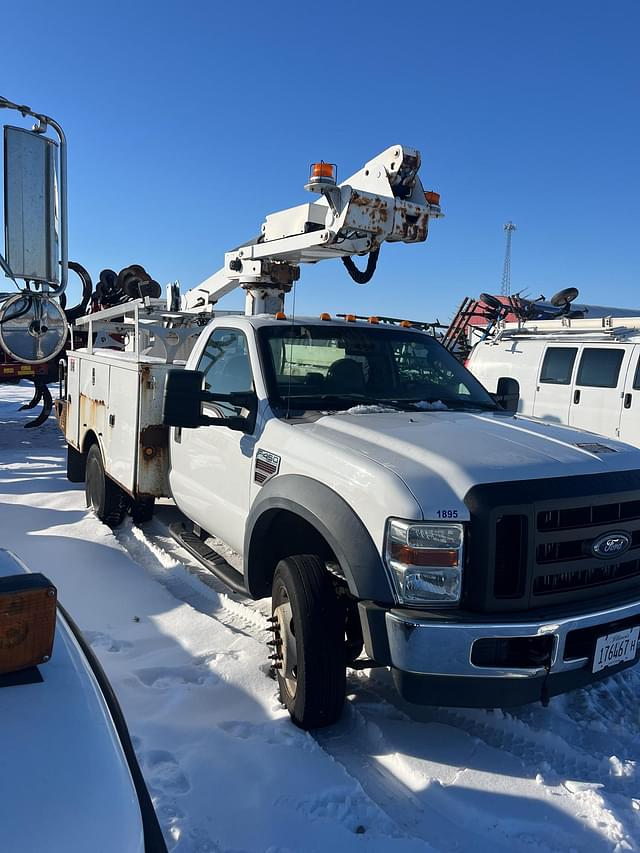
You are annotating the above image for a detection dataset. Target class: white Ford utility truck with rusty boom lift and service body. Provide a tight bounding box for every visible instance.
[57,146,640,727]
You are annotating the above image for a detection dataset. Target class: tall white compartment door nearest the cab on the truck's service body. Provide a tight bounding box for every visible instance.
[103,364,138,493]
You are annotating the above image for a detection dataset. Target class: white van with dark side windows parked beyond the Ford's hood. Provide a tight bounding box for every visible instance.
[467,317,640,446]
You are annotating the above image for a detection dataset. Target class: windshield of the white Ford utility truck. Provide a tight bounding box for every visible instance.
[258,323,497,411]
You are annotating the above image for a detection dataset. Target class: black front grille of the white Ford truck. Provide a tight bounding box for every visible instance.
[465,471,640,611]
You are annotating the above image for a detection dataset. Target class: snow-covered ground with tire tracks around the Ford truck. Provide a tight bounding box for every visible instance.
[0,383,640,853]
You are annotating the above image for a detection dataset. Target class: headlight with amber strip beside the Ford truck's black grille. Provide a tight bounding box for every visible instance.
[385,518,464,605]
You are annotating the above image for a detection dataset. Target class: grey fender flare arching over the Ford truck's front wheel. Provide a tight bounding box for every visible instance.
[244,474,394,604]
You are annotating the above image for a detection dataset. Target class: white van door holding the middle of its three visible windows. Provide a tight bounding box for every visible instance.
[569,343,634,438]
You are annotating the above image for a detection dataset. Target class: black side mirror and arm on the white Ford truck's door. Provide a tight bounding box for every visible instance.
[162,370,258,432]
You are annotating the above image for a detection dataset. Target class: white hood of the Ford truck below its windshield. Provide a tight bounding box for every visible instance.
[303,411,640,518]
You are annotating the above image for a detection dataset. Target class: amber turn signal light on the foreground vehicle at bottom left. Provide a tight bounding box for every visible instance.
[0,573,57,674]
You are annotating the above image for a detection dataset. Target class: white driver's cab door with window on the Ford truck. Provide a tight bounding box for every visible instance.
[170,328,256,552]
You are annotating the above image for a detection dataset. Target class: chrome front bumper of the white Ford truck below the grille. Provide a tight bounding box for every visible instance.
[385,601,640,679]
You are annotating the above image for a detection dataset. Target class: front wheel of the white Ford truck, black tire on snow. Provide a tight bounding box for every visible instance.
[271,555,346,729]
